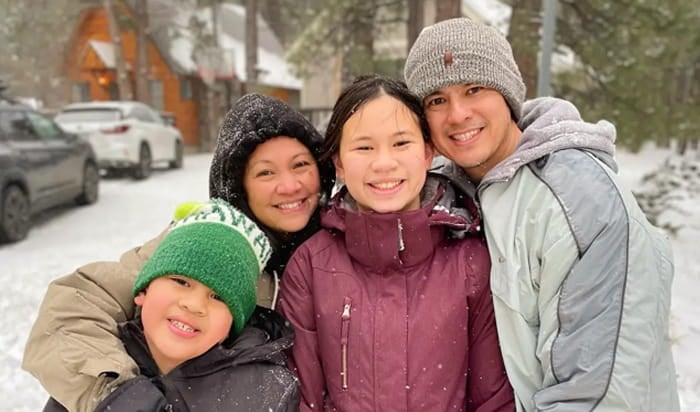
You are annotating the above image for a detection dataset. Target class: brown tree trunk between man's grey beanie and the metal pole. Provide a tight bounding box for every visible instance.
[508,0,542,98]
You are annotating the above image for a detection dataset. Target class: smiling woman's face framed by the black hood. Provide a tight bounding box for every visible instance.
[243,136,321,233]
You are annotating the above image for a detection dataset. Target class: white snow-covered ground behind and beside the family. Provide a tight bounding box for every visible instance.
[0,149,700,412]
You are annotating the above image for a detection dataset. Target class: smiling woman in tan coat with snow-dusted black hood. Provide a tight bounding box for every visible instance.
[22,94,335,411]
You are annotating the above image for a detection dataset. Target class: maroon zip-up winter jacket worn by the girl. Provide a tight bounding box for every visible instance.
[278,179,513,412]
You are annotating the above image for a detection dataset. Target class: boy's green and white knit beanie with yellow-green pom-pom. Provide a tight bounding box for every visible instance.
[133,199,272,336]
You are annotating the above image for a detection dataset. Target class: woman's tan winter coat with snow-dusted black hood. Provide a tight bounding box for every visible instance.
[22,94,335,411]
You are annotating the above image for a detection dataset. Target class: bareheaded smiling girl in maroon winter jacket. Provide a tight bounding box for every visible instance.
[278,77,514,411]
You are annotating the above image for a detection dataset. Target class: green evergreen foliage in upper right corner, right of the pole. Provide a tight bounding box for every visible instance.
[555,0,700,151]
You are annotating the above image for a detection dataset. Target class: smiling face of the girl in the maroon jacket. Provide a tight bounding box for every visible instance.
[333,95,433,213]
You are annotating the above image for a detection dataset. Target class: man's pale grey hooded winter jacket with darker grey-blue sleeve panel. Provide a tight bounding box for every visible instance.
[443,98,679,412]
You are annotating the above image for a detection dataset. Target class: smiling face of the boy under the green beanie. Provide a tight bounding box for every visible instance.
[134,275,233,374]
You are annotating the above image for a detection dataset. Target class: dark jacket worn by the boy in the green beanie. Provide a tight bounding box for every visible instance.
[44,306,299,412]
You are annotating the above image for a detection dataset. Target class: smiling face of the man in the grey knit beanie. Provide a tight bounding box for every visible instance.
[423,84,521,182]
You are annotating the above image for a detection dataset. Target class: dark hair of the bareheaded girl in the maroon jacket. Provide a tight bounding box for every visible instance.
[320,75,430,160]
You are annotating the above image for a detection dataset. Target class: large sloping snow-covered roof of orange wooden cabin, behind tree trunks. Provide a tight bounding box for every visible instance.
[149,1,302,90]
